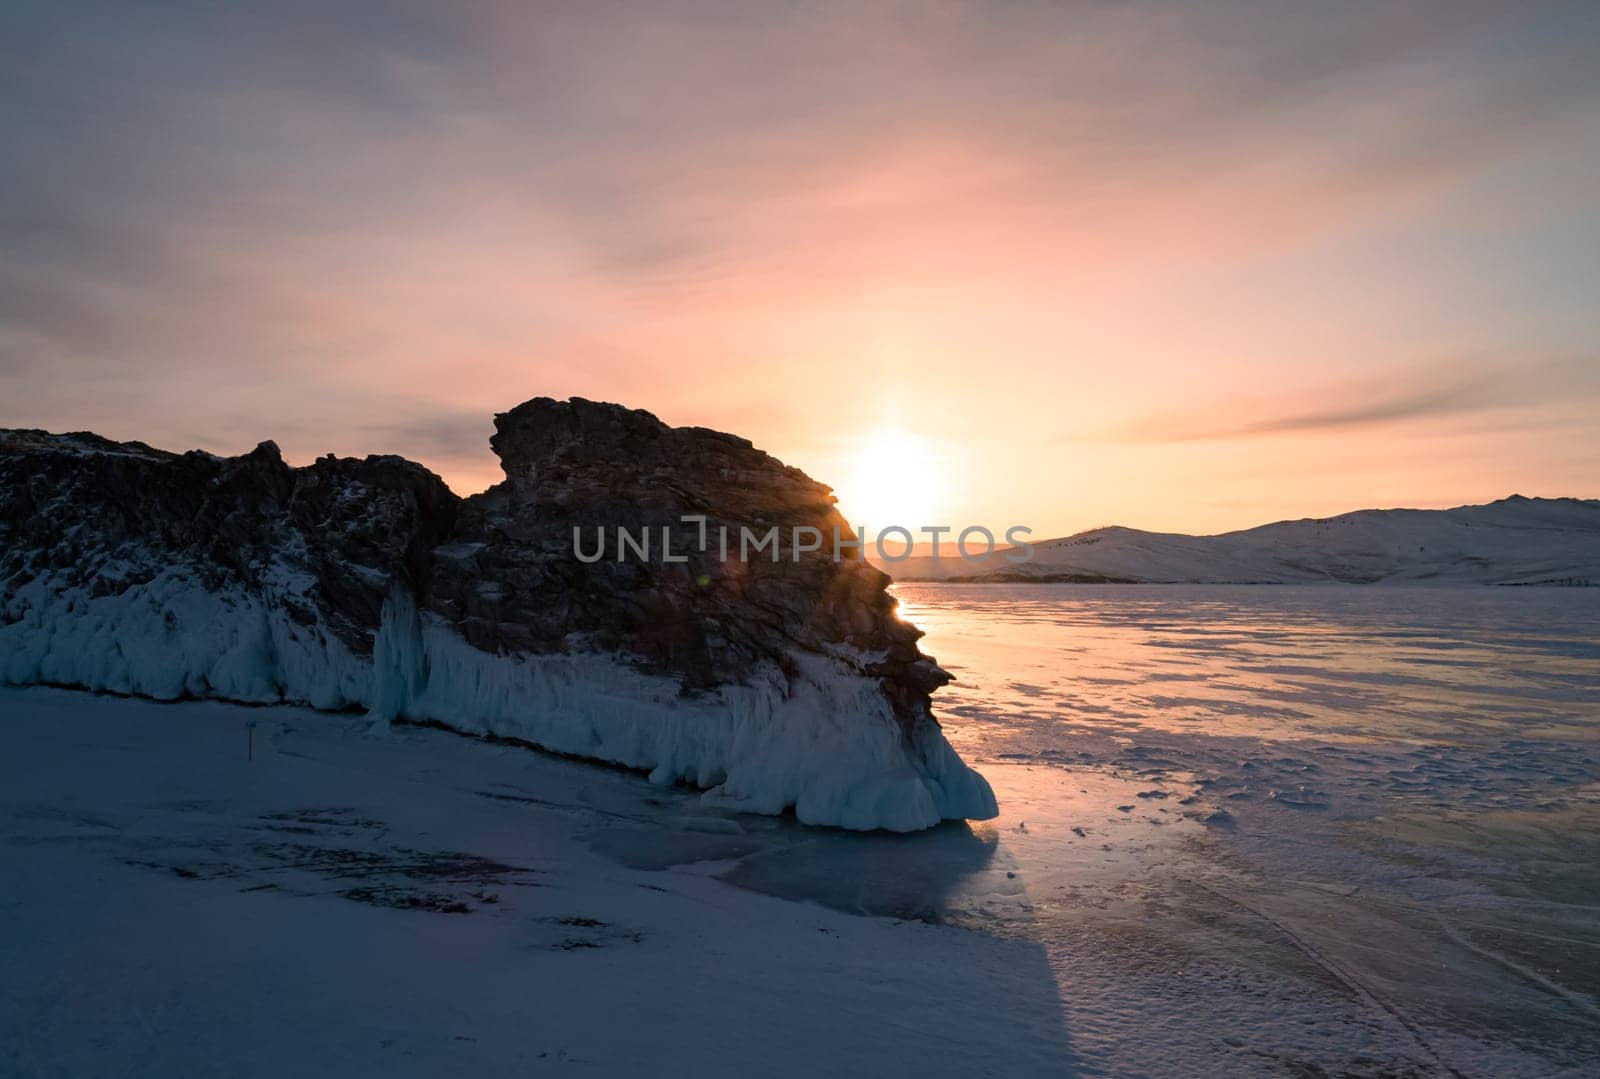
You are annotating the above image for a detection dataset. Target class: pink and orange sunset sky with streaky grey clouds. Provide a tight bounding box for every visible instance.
[0,0,1600,538]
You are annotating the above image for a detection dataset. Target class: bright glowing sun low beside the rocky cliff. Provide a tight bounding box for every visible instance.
[834,427,944,535]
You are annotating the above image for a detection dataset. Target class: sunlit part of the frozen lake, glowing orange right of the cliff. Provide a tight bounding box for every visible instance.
[720,584,1600,1074]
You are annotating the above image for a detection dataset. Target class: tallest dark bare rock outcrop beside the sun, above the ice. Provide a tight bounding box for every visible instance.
[426,397,949,725]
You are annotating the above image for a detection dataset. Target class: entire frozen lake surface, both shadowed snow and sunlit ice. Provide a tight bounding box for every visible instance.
[0,584,1600,1076]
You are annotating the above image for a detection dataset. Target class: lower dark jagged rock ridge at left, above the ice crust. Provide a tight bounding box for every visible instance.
[0,431,459,655]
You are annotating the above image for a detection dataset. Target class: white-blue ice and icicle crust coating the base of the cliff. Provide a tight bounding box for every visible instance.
[0,568,995,831]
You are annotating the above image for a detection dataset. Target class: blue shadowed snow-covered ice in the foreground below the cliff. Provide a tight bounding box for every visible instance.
[0,688,1074,1077]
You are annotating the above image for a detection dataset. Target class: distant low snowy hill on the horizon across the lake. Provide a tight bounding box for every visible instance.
[883,495,1600,584]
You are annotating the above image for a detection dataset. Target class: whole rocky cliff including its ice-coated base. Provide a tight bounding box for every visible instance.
[0,399,994,831]
